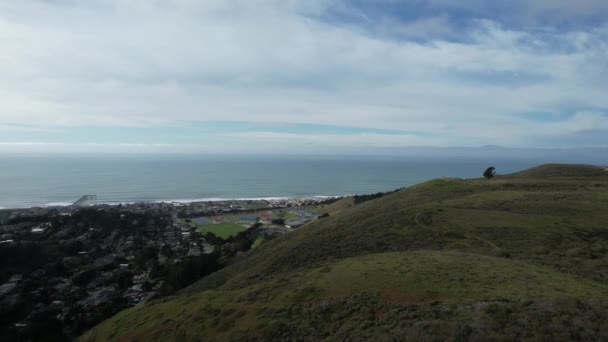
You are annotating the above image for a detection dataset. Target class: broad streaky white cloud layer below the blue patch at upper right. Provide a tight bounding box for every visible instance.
[0,0,608,151]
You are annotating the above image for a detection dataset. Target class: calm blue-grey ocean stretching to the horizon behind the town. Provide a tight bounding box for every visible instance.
[0,155,592,208]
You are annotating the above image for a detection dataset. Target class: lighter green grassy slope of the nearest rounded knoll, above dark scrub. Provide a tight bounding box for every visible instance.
[82,251,608,341]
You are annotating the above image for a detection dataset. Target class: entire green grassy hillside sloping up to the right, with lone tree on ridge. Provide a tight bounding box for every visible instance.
[81,165,608,341]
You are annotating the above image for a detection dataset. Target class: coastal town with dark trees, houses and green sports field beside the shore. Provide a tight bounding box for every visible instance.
[0,197,337,341]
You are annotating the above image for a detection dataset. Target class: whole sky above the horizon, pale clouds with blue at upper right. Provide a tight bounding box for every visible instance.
[0,0,608,154]
